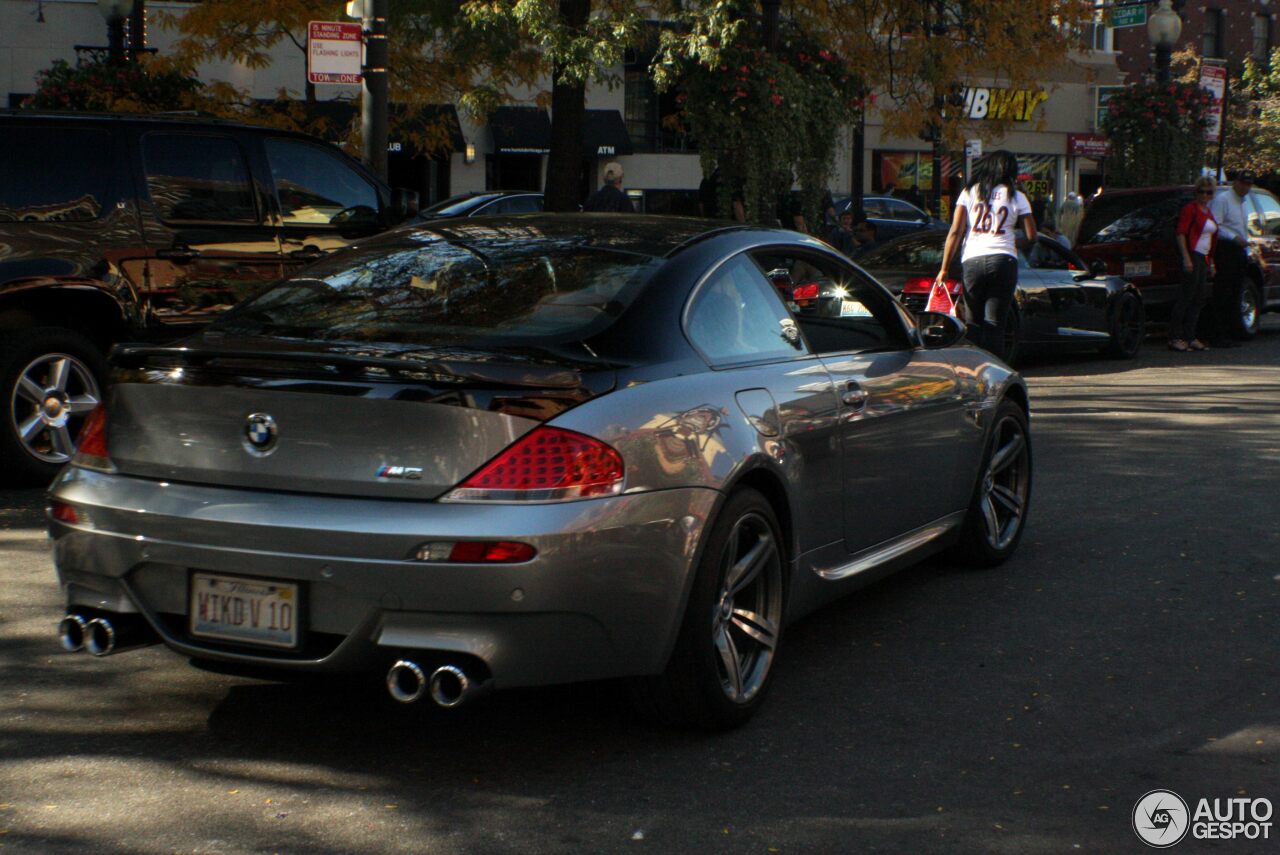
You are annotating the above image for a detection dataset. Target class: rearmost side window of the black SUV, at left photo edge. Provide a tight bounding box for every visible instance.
[0,127,115,223]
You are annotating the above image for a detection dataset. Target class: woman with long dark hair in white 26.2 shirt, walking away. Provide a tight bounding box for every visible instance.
[937,151,1036,358]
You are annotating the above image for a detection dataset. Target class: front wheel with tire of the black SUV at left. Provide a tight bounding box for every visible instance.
[0,326,106,484]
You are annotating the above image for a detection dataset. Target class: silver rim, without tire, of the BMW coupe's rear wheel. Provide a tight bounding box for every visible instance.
[712,512,782,703]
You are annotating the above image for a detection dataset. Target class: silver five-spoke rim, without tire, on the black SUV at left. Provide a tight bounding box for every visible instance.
[9,353,102,463]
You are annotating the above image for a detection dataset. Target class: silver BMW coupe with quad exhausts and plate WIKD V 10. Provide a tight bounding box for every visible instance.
[50,215,1032,727]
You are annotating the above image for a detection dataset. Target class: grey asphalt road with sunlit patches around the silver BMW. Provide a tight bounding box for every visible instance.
[0,317,1280,855]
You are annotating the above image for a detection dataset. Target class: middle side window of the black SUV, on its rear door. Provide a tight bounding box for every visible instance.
[142,133,257,223]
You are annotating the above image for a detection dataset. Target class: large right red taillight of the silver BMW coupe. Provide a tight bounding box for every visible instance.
[445,426,623,502]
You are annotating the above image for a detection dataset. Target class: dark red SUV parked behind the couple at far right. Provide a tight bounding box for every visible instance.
[1075,184,1280,339]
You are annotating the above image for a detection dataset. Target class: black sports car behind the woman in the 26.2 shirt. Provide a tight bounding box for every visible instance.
[858,232,1147,365]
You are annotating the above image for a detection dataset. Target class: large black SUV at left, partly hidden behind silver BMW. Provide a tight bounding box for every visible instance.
[0,110,417,481]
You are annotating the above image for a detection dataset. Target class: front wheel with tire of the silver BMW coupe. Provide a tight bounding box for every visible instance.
[952,399,1032,567]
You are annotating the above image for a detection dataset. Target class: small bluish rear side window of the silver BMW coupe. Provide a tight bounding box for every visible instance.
[686,256,804,365]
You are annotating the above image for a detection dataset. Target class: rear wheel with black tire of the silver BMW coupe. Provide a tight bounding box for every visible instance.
[635,489,785,730]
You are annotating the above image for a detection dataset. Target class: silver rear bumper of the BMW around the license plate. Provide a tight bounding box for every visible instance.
[50,468,719,686]
